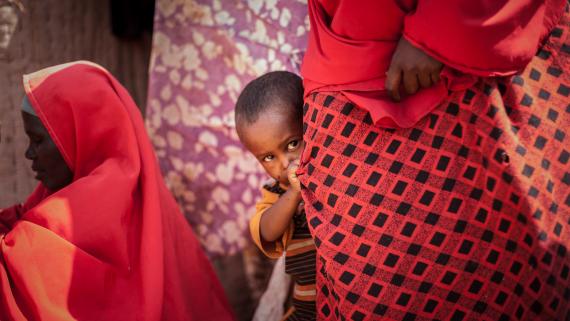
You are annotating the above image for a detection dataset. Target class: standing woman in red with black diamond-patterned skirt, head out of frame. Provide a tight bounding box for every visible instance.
[298,0,570,320]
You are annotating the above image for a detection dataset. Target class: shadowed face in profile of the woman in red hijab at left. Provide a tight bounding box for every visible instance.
[22,112,73,191]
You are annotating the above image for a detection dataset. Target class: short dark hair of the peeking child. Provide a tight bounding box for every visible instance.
[235,71,303,127]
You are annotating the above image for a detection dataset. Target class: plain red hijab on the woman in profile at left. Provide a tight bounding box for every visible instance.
[0,62,233,321]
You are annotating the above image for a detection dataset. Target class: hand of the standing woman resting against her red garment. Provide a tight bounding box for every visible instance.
[386,37,443,101]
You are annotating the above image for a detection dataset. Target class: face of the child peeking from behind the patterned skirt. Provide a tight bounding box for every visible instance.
[240,108,304,186]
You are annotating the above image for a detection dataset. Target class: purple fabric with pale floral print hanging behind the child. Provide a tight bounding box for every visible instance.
[147,0,309,257]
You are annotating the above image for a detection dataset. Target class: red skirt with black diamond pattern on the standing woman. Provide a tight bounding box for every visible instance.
[298,1,570,321]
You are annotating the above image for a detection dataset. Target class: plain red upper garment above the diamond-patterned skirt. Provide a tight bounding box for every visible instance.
[301,0,566,128]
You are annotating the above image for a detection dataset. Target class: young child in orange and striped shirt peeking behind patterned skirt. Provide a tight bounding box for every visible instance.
[235,71,316,320]
